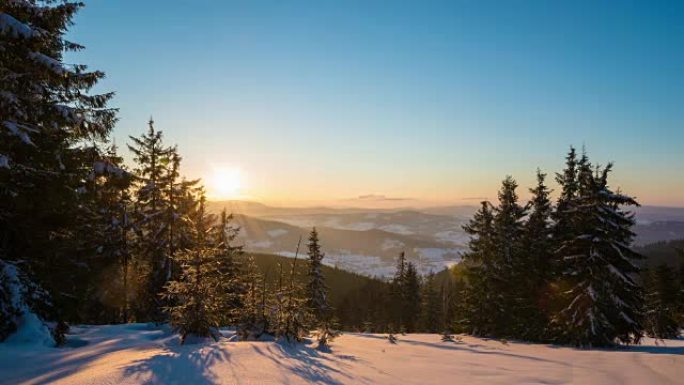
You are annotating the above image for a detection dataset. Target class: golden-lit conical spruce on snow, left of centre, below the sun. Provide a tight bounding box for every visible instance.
[162,192,230,343]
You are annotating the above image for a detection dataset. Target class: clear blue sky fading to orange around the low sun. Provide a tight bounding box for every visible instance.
[67,0,684,206]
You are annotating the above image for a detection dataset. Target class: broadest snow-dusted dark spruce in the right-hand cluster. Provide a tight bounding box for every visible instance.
[556,160,643,347]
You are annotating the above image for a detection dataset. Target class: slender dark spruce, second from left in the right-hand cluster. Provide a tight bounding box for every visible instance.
[493,176,530,337]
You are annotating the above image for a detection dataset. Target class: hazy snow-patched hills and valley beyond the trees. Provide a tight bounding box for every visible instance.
[210,201,684,276]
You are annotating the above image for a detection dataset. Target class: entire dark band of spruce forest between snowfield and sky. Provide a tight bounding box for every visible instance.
[0,1,684,346]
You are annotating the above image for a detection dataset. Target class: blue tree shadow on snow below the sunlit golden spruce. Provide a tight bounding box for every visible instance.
[124,344,230,385]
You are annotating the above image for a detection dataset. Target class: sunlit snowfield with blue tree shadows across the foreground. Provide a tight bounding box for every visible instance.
[0,324,684,385]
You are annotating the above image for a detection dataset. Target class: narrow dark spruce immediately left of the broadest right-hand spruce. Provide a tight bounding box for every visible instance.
[514,170,553,341]
